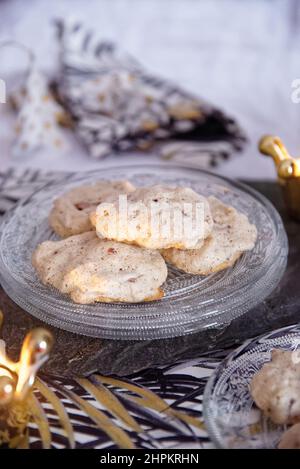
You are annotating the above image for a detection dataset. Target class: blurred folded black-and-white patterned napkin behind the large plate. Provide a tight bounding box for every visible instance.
[54,21,245,167]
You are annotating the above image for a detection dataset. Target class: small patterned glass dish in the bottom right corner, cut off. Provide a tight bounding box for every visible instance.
[203,324,300,449]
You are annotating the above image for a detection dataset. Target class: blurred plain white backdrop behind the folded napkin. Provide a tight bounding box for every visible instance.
[0,0,300,178]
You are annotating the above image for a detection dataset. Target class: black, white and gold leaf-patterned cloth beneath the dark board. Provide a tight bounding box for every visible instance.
[0,169,229,449]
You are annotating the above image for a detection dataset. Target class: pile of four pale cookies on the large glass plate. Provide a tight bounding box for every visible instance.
[32,181,257,304]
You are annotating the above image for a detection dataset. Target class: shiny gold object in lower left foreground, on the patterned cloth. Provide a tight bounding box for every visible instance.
[0,311,53,448]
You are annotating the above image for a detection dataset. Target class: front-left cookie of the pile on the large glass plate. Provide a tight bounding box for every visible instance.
[32,231,167,304]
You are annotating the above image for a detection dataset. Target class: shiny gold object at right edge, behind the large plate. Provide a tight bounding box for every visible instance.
[259,135,300,220]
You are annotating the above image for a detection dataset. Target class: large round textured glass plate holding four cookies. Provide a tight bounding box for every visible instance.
[0,164,288,339]
